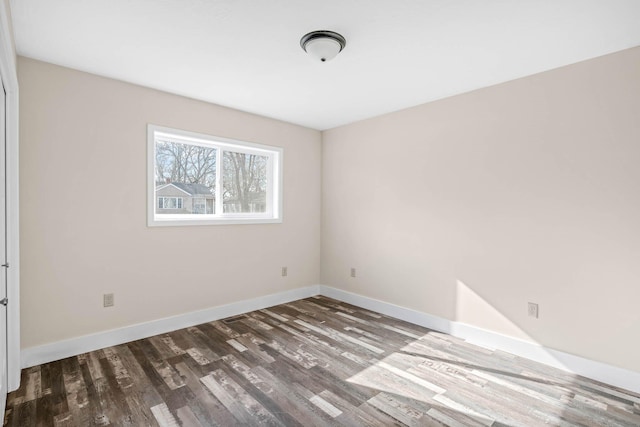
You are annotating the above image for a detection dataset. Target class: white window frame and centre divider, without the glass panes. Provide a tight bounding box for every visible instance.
[147,124,283,227]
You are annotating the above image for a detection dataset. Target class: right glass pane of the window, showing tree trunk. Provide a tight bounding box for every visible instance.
[222,151,269,213]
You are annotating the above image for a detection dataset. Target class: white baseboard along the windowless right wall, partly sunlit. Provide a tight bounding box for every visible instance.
[320,285,640,393]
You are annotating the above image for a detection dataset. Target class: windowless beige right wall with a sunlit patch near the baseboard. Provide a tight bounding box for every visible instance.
[321,48,640,371]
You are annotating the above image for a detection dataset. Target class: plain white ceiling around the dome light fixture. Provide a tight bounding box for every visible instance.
[11,0,640,130]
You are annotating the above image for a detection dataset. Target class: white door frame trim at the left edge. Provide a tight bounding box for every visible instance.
[0,0,21,391]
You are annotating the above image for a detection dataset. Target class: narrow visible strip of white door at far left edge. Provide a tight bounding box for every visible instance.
[0,75,7,412]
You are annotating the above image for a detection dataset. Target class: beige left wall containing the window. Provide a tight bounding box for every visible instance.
[18,58,321,348]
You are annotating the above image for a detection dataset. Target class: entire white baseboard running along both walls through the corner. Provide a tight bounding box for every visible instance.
[21,285,640,393]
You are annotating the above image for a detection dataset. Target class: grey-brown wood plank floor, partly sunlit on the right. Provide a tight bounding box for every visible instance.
[5,297,640,427]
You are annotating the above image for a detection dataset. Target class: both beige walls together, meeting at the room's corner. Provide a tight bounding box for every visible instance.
[19,48,640,371]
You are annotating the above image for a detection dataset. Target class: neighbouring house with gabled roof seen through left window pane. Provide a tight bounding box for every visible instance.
[156,182,215,214]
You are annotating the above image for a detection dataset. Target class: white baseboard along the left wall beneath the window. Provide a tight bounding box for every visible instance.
[20,285,320,368]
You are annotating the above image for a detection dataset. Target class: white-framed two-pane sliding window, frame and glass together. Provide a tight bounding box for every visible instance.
[147,125,282,226]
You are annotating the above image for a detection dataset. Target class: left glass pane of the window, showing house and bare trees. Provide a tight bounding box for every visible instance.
[155,139,217,214]
